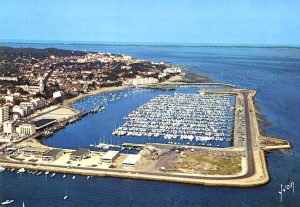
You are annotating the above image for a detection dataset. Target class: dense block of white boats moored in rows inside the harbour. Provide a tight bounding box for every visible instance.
[112,93,234,141]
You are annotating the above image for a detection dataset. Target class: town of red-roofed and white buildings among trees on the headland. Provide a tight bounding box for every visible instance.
[0,47,182,143]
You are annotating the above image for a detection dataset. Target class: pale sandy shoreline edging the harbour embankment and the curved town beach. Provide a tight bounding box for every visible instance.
[0,76,291,187]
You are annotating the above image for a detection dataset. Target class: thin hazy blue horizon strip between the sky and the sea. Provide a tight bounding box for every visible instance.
[0,40,300,49]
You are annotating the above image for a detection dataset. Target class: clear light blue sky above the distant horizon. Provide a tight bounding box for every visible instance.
[0,0,300,46]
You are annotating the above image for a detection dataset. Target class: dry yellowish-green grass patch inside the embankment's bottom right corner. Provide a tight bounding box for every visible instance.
[174,152,242,175]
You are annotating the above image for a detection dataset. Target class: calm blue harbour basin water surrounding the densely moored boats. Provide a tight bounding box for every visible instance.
[42,86,234,151]
